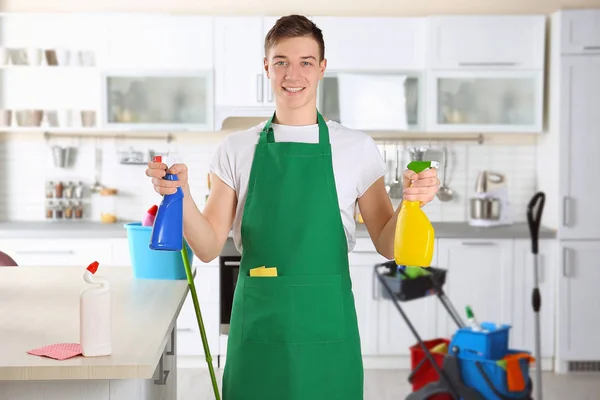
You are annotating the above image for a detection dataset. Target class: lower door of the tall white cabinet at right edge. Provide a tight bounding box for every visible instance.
[556,241,600,368]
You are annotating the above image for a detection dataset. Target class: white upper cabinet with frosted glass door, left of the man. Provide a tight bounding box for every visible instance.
[100,14,214,131]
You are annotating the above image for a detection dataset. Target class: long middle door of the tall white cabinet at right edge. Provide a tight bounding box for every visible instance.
[556,54,600,239]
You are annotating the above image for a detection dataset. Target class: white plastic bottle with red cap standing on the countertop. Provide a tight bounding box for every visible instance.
[79,261,112,357]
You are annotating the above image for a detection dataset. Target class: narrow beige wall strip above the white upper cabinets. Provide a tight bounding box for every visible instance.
[2,0,600,16]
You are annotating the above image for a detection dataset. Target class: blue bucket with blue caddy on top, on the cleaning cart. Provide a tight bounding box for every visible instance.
[449,322,532,400]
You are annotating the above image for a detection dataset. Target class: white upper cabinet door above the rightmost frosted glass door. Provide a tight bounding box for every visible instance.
[429,15,546,71]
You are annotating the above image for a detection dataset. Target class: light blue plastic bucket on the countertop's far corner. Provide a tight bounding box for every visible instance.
[125,222,194,280]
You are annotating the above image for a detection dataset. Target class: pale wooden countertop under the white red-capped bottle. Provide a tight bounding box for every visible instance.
[0,265,189,381]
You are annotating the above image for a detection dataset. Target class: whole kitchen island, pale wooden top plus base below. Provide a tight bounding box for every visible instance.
[0,265,190,400]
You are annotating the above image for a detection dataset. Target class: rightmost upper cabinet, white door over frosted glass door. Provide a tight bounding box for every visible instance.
[427,15,545,133]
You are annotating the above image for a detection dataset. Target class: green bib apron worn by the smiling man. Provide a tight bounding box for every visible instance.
[223,114,363,400]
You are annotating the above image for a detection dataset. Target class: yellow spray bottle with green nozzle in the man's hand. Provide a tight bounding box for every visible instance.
[394,161,438,268]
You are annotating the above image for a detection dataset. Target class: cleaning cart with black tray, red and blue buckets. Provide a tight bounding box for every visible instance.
[375,261,533,400]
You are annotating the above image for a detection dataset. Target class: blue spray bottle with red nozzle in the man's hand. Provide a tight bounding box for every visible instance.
[150,156,183,251]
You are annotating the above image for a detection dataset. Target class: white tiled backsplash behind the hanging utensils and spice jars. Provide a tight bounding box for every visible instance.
[0,134,536,222]
